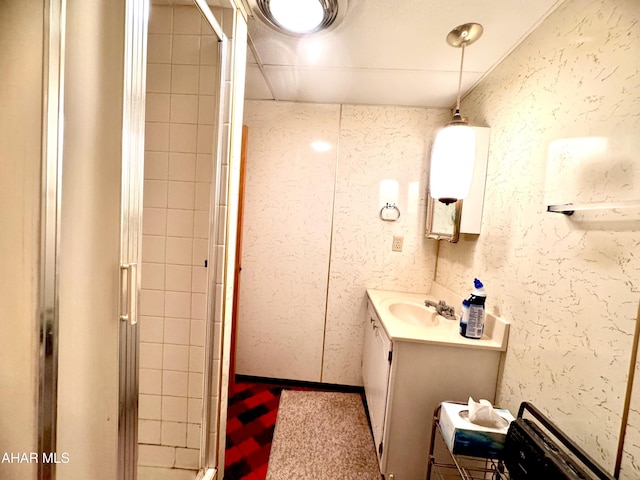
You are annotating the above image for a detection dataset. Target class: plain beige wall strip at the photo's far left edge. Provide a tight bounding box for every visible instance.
[0,0,44,480]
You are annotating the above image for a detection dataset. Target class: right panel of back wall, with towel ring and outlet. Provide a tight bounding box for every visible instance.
[322,105,450,385]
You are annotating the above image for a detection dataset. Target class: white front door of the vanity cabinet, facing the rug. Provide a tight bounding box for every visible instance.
[362,306,391,460]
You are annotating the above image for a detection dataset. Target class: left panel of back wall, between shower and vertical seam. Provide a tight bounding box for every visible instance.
[236,102,340,382]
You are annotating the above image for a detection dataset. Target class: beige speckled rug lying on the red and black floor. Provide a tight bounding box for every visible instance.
[267,390,380,480]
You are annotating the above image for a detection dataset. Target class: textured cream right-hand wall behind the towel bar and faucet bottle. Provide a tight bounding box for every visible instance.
[437,0,640,472]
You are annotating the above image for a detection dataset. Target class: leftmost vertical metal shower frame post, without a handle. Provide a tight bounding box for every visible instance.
[37,0,66,479]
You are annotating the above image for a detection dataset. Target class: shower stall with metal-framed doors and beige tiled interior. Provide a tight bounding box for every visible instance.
[14,0,246,480]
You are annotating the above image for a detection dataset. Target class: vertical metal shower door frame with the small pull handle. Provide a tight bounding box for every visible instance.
[118,0,150,480]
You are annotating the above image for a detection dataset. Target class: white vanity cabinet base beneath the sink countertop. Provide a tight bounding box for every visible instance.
[362,292,501,480]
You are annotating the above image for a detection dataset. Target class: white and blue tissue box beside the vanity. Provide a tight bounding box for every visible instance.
[440,402,514,458]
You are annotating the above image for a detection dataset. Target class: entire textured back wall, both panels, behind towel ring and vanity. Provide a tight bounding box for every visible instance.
[237,101,449,385]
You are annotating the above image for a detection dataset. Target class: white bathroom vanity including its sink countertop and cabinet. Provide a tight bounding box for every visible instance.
[362,290,509,480]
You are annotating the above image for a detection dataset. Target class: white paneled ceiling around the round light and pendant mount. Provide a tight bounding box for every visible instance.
[245,0,562,107]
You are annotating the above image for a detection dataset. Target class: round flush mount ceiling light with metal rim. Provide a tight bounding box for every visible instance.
[253,0,347,35]
